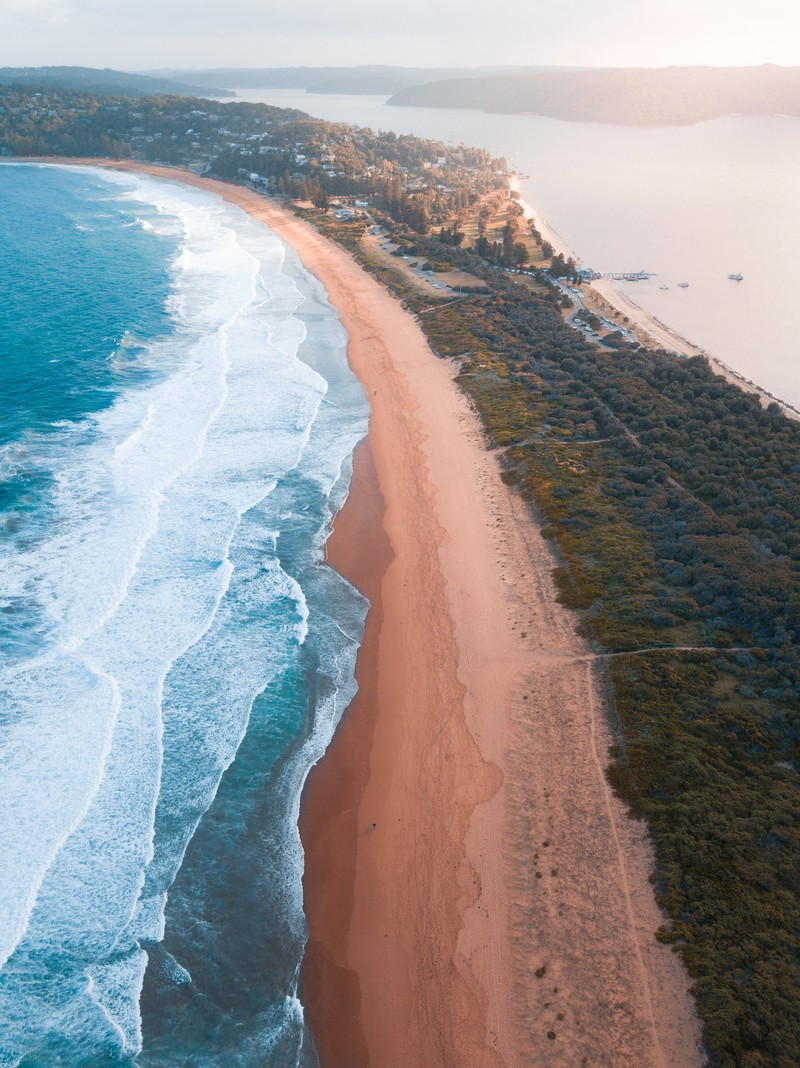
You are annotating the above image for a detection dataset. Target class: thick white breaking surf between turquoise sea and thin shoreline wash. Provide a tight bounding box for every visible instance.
[0,174,365,1064]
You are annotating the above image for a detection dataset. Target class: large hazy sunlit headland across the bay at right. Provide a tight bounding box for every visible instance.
[388,65,800,126]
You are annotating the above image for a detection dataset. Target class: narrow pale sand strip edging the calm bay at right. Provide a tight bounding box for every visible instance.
[511,175,800,419]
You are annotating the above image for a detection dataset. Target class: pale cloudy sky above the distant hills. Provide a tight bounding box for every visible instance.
[0,0,800,70]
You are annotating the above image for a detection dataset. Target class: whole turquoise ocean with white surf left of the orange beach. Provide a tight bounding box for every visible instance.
[0,164,368,1068]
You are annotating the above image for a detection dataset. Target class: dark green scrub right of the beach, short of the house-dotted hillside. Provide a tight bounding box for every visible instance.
[337,212,800,1068]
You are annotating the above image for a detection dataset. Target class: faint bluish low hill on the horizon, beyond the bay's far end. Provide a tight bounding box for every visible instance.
[151,65,552,95]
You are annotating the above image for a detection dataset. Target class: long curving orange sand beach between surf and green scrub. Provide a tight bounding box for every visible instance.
[77,161,702,1068]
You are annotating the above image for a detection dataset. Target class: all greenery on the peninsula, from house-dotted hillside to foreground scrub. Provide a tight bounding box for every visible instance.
[6,90,800,1068]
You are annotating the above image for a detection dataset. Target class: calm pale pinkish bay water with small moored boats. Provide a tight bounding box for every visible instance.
[230,90,800,407]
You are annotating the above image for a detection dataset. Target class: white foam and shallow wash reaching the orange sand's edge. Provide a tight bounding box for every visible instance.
[0,166,366,1065]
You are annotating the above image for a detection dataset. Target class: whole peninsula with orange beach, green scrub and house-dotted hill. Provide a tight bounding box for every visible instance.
[6,81,800,1066]
